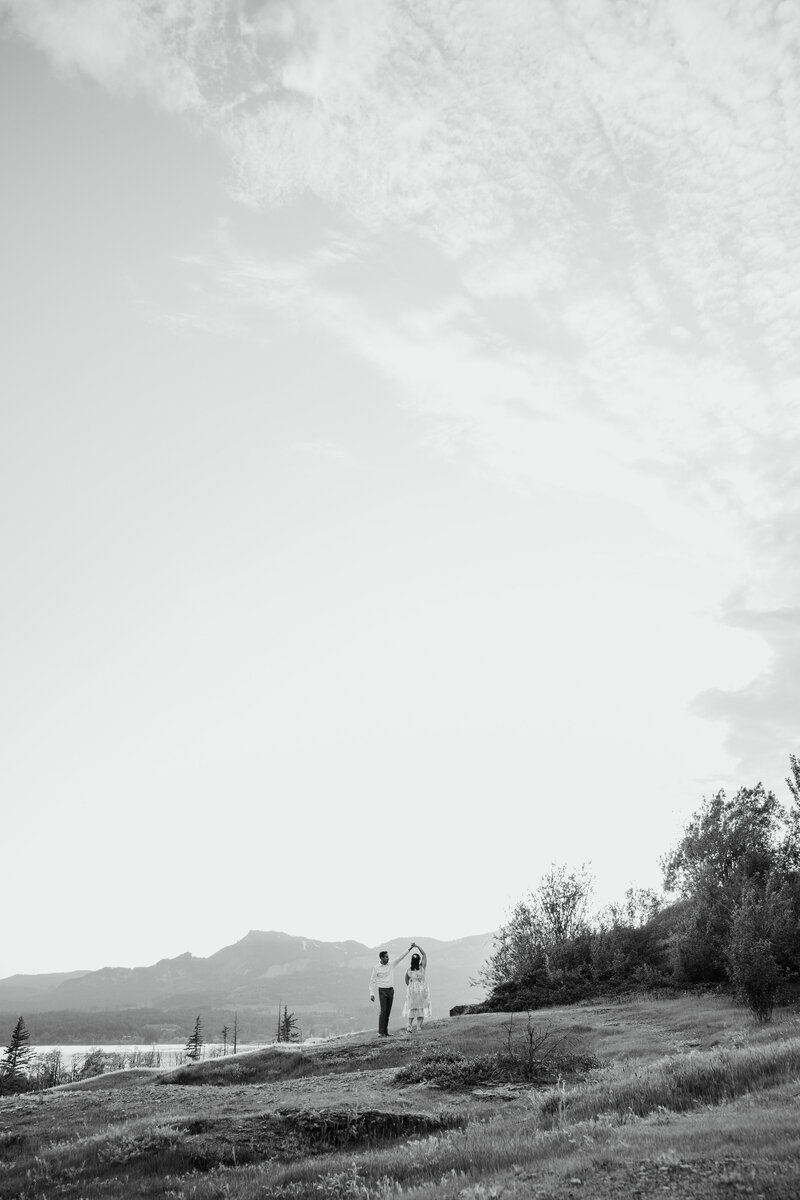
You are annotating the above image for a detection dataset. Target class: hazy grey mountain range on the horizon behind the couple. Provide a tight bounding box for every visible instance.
[0,930,494,1042]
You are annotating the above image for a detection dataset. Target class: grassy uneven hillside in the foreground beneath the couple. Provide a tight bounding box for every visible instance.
[0,997,800,1200]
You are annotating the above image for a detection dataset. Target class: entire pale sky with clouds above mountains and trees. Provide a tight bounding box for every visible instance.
[0,0,800,977]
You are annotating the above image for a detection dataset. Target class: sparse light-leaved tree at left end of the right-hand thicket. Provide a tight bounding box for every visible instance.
[479,864,593,989]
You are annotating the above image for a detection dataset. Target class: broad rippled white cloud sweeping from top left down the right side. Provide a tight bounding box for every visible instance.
[6,0,800,777]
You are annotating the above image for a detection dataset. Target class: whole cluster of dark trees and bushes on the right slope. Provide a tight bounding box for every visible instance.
[471,755,800,1021]
